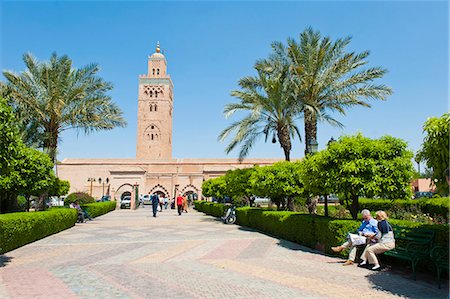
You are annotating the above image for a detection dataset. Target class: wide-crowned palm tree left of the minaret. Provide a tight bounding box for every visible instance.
[1,53,126,163]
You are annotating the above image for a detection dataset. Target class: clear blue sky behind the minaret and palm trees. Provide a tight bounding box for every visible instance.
[0,1,449,160]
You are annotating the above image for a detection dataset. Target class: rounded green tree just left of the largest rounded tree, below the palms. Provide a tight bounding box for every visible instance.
[250,161,304,211]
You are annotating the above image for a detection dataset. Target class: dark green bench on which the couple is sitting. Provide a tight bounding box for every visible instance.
[384,226,435,280]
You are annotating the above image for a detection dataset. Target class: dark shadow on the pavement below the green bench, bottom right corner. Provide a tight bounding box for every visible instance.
[367,269,448,298]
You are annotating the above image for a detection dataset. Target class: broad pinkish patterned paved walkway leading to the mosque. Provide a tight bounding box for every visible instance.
[0,207,448,299]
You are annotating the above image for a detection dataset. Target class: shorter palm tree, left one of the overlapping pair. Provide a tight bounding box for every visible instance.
[219,45,300,161]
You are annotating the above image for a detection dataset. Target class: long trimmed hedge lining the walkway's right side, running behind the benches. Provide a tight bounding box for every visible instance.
[195,202,449,254]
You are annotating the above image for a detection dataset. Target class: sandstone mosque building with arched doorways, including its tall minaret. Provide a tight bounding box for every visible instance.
[57,43,279,204]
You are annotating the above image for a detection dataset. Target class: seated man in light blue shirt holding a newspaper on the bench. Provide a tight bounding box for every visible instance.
[331,210,378,266]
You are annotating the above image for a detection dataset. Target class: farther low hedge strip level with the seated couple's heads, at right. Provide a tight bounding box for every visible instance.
[359,197,450,219]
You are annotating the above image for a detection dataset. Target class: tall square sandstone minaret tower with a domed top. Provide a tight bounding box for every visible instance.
[136,42,173,159]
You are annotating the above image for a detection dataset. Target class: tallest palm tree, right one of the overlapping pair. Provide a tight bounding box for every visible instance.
[287,27,392,154]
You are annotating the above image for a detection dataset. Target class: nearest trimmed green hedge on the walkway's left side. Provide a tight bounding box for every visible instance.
[0,209,77,253]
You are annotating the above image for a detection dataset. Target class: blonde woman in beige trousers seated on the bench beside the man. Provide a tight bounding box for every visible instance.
[359,211,395,270]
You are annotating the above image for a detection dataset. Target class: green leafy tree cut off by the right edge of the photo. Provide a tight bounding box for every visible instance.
[417,112,450,195]
